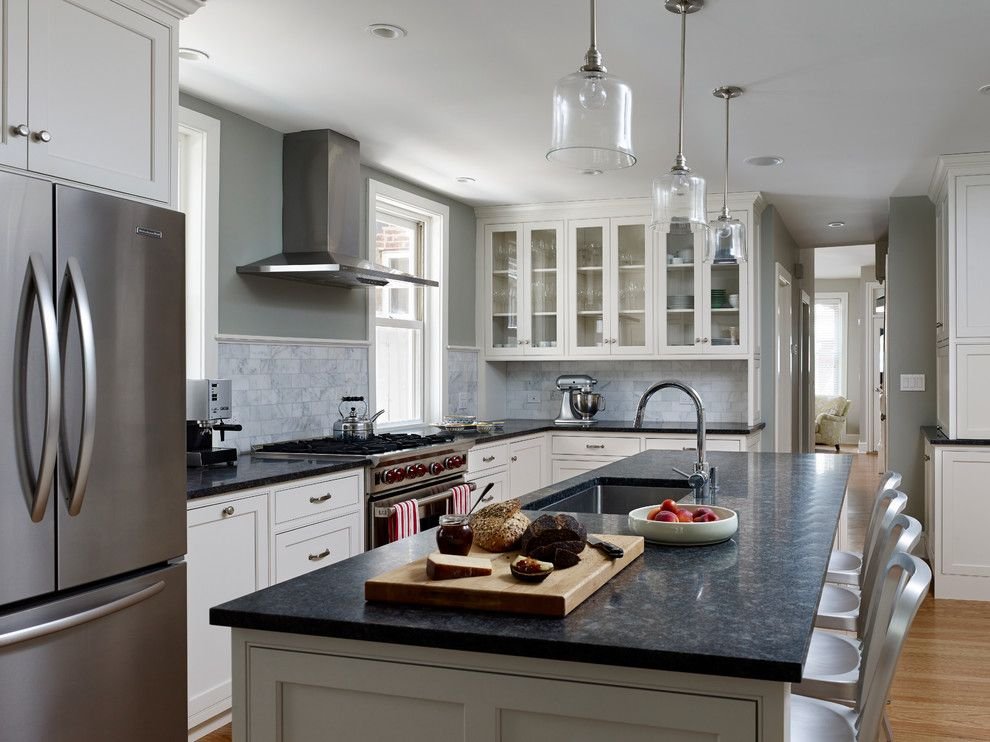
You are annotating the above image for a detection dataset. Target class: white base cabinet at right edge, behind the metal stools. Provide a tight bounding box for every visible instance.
[925,444,990,600]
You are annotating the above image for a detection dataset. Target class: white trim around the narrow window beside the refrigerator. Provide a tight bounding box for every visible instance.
[178,106,220,378]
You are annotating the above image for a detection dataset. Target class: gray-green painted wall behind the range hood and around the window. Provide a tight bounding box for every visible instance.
[179,93,475,345]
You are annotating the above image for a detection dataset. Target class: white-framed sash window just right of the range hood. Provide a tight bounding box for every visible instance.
[368,180,449,428]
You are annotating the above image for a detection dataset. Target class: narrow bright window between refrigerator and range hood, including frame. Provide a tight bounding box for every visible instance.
[178,107,220,379]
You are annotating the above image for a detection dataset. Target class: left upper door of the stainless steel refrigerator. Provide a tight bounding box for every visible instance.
[0,173,58,605]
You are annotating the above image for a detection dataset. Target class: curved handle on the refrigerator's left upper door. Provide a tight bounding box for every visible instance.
[14,253,62,523]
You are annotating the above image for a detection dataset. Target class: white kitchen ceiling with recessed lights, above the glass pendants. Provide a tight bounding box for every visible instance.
[180,0,990,246]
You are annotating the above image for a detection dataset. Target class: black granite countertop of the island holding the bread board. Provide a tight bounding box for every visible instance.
[210,451,852,682]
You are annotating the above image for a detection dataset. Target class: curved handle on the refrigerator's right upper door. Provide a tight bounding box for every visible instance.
[58,257,96,515]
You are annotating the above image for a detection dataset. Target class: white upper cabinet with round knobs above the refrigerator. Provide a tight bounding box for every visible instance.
[0,0,188,202]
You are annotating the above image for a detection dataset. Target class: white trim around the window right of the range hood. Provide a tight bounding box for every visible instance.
[367,178,450,430]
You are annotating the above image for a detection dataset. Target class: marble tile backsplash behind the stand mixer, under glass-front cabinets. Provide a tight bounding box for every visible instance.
[505,360,747,422]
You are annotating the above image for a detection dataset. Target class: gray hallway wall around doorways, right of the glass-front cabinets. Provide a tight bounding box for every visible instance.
[759,206,815,451]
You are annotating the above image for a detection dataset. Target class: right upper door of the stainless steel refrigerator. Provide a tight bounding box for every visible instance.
[55,186,186,588]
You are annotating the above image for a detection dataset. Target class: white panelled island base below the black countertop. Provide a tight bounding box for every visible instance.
[234,629,789,742]
